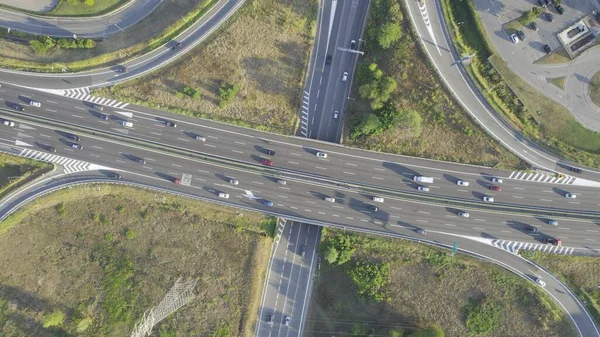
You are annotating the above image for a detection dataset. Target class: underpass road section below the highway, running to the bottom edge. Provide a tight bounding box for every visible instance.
[255,220,321,337]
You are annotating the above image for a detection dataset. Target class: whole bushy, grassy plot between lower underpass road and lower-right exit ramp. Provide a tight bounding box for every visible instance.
[306,229,577,337]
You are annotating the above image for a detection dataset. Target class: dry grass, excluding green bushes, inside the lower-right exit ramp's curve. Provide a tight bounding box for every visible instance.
[306,231,576,337]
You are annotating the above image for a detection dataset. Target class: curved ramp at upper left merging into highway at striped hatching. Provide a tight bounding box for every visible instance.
[0,0,244,90]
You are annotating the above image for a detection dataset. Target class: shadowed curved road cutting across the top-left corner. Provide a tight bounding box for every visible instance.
[0,0,163,39]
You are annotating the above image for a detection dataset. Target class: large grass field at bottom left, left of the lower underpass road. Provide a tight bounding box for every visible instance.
[0,185,272,337]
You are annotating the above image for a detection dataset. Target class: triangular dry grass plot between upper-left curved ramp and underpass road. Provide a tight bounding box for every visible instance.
[93,0,318,134]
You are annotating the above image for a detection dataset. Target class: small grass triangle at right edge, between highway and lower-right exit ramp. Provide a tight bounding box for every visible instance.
[520,251,600,325]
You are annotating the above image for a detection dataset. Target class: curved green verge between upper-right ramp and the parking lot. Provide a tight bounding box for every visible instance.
[442,0,600,167]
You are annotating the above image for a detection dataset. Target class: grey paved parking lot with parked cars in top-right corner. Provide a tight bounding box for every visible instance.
[473,0,600,63]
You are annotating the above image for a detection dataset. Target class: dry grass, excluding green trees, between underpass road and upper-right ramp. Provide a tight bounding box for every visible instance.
[345,0,521,169]
